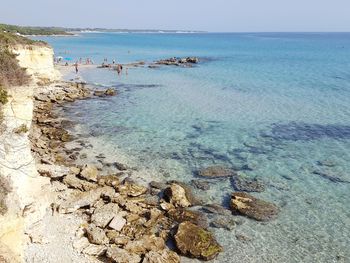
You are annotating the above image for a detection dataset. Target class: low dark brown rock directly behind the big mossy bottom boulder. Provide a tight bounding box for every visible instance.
[167,208,208,228]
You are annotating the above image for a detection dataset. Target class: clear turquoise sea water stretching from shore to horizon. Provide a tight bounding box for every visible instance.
[34,33,350,262]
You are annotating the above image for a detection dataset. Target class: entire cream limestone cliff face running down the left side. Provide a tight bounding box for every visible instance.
[0,42,60,263]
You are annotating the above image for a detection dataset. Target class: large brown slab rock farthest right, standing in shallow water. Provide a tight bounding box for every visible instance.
[230,192,279,221]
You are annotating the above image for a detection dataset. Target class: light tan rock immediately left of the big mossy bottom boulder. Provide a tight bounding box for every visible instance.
[124,235,165,255]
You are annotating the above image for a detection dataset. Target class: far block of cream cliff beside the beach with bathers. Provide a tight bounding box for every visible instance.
[11,45,60,80]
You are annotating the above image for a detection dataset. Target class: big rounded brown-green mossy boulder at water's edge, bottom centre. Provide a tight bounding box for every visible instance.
[175,222,223,260]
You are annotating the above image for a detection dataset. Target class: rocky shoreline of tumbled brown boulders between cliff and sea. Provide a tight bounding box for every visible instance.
[25,77,278,263]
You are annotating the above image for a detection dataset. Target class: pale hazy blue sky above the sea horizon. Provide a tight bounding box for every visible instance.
[0,0,350,32]
